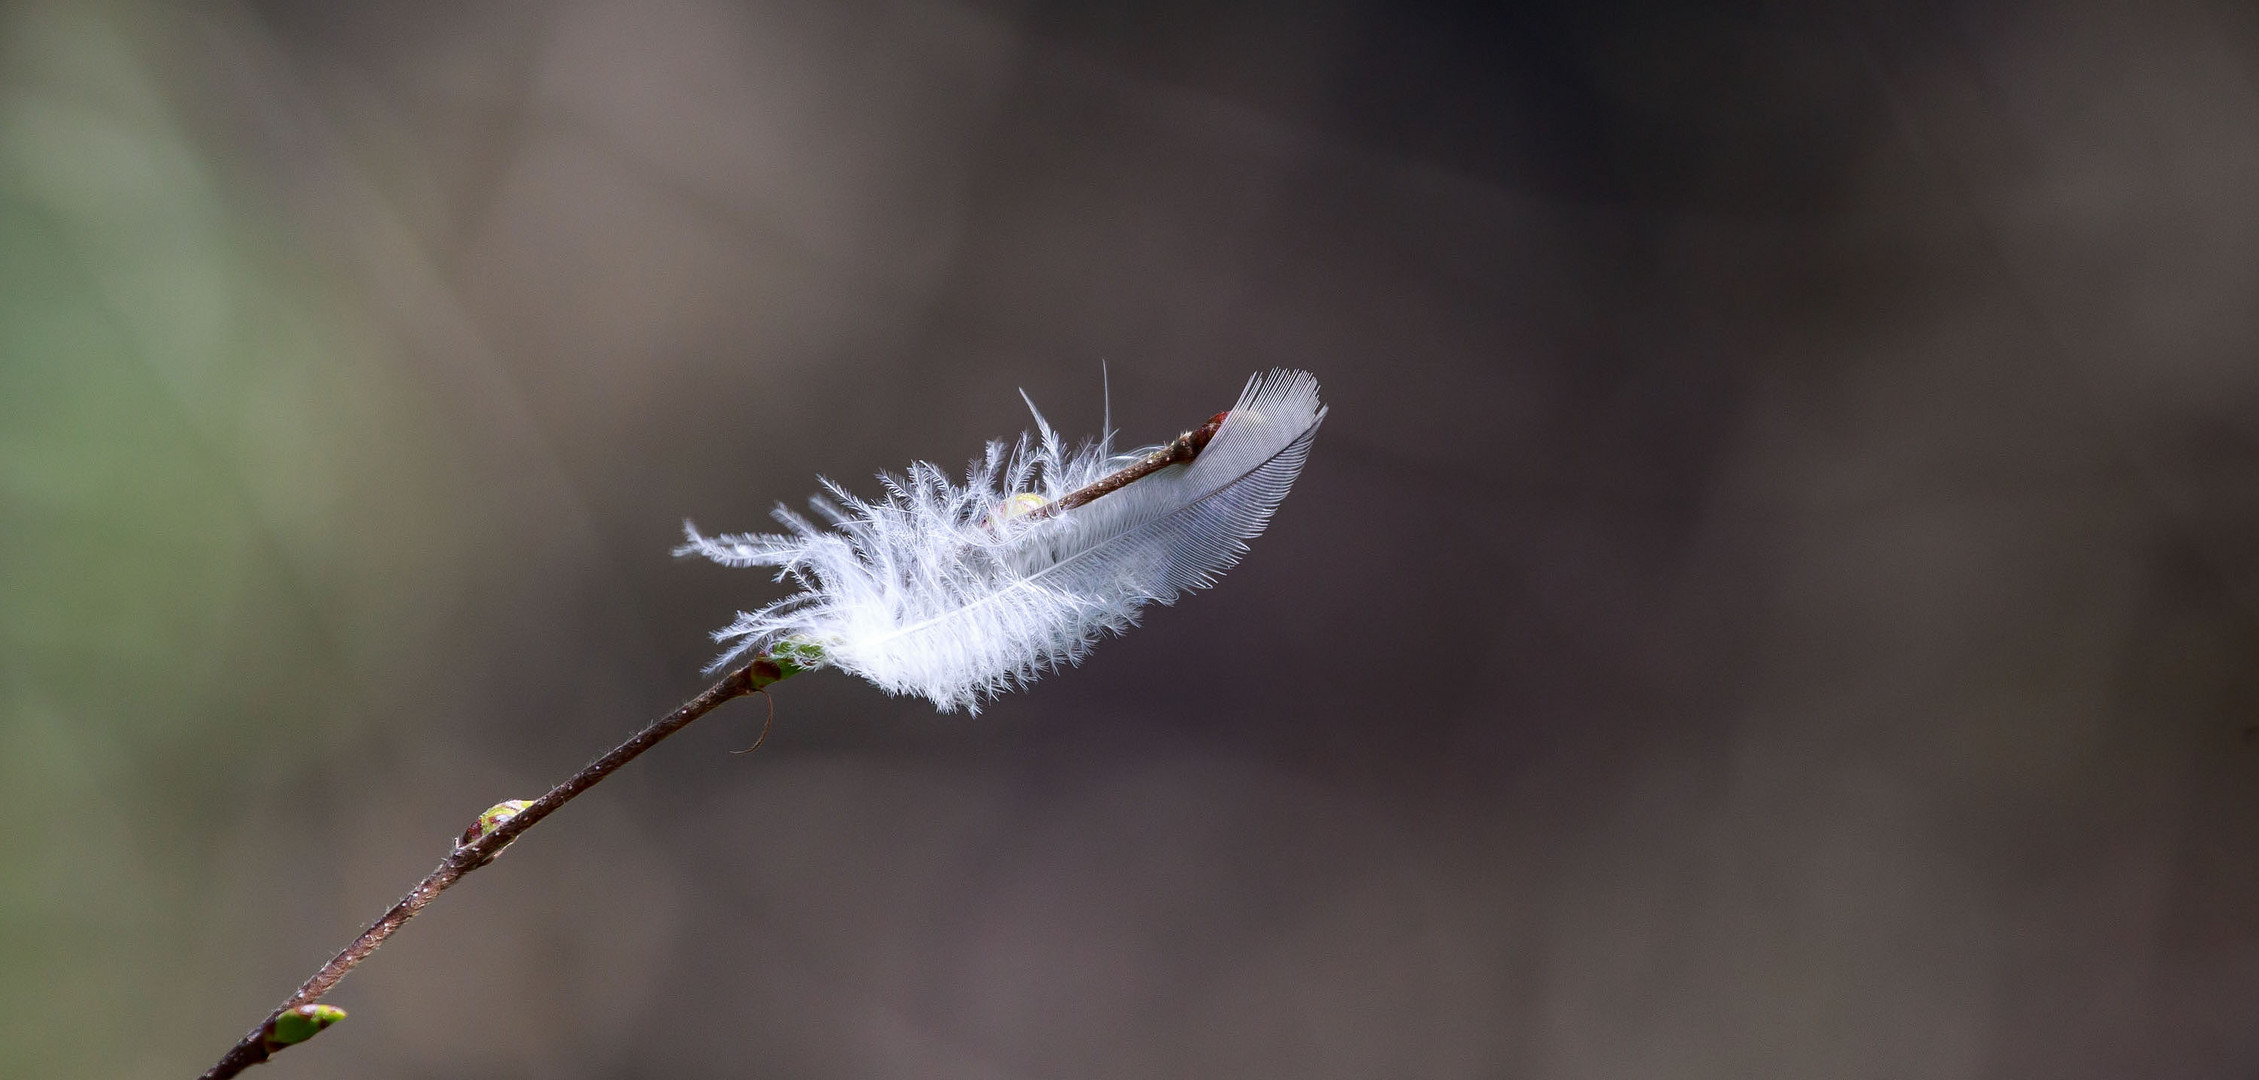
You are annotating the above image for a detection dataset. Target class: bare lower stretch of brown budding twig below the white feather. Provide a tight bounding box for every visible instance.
[203,655,797,1080]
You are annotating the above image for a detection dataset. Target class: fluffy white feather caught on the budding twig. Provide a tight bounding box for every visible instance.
[675,371,1326,712]
